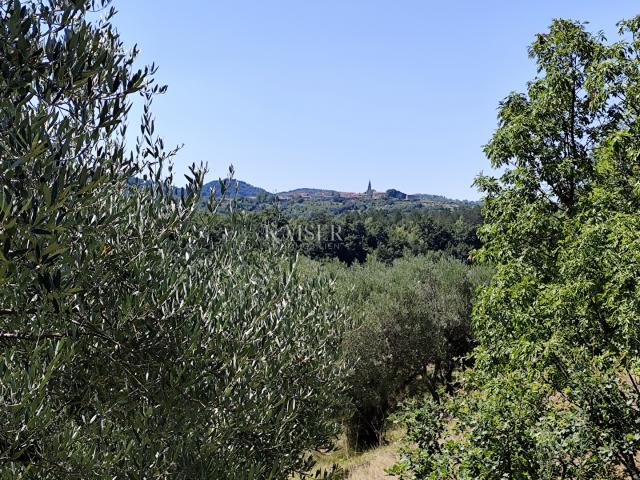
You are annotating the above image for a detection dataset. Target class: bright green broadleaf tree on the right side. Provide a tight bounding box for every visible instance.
[402,17,640,479]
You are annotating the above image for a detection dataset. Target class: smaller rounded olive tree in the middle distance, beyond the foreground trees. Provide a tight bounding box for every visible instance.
[316,254,490,449]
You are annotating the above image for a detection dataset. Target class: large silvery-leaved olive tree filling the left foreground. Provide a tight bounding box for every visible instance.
[0,0,342,479]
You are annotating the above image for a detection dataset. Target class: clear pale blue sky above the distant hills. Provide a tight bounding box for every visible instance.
[115,0,640,199]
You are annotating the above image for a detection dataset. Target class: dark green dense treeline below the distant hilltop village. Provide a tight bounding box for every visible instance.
[212,206,482,265]
